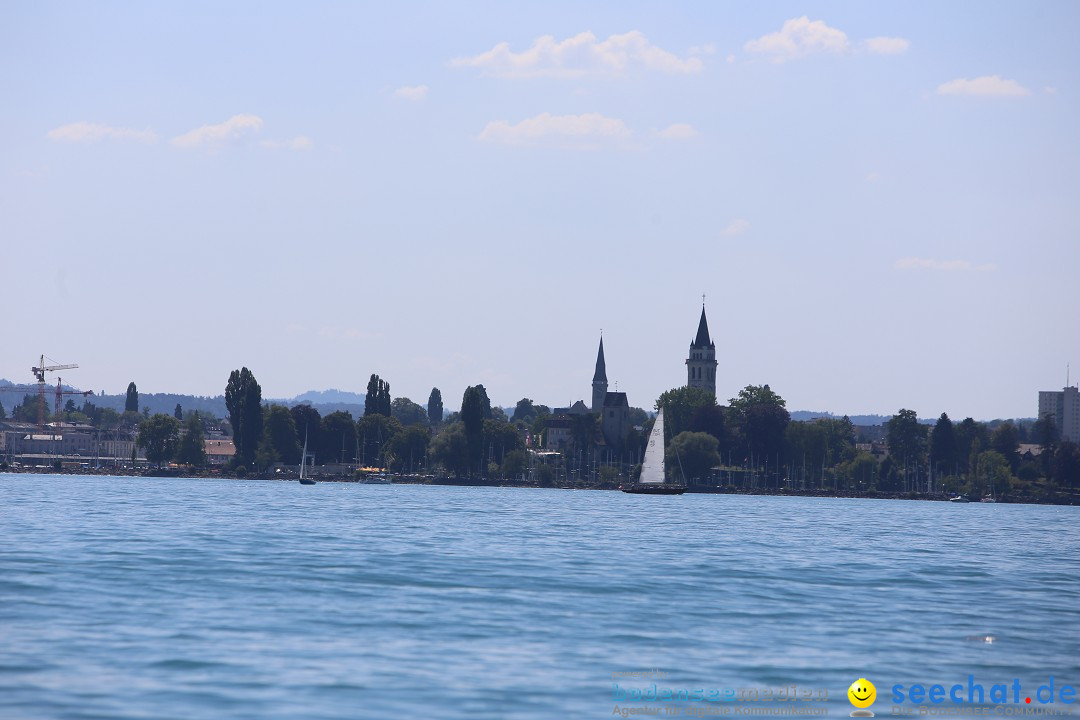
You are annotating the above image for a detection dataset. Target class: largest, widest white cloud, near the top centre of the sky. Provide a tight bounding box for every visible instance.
[449,30,704,78]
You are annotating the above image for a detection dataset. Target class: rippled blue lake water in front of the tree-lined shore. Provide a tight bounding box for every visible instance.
[0,475,1080,720]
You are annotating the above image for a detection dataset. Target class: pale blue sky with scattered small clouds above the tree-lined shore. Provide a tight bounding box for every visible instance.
[0,0,1080,420]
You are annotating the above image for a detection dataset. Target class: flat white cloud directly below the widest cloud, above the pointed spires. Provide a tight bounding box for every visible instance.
[478,112,632,149]
